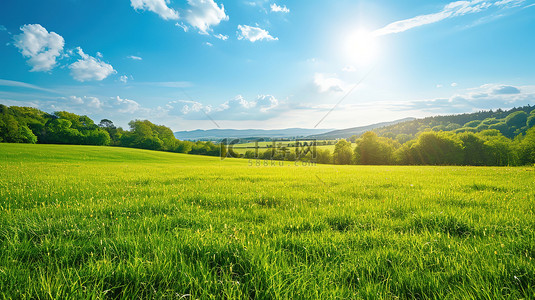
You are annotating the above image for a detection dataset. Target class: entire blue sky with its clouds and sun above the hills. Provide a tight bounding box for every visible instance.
[0,0,535,131]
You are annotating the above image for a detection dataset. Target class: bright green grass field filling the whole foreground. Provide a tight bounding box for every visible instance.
[0,144,535,299]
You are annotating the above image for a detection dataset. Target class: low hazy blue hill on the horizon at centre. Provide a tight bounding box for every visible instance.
[175,128,332,141]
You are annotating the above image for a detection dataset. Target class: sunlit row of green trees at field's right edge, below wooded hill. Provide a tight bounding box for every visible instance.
[246,128,535,166]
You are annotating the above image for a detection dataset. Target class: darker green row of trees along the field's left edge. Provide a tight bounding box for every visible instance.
[0,104,220,156]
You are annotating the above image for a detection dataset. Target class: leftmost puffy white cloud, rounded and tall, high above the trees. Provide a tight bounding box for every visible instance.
[13,24,65,72]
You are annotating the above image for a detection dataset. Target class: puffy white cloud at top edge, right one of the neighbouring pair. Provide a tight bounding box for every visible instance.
[186,0,229,34]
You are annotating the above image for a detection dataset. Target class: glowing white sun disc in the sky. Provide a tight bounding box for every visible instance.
[345,29,380,65]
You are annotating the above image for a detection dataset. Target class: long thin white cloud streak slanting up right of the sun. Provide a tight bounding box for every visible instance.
[374,0,525,36]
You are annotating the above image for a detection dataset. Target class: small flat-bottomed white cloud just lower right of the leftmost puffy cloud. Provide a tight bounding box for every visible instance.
[69,47,117,82]
